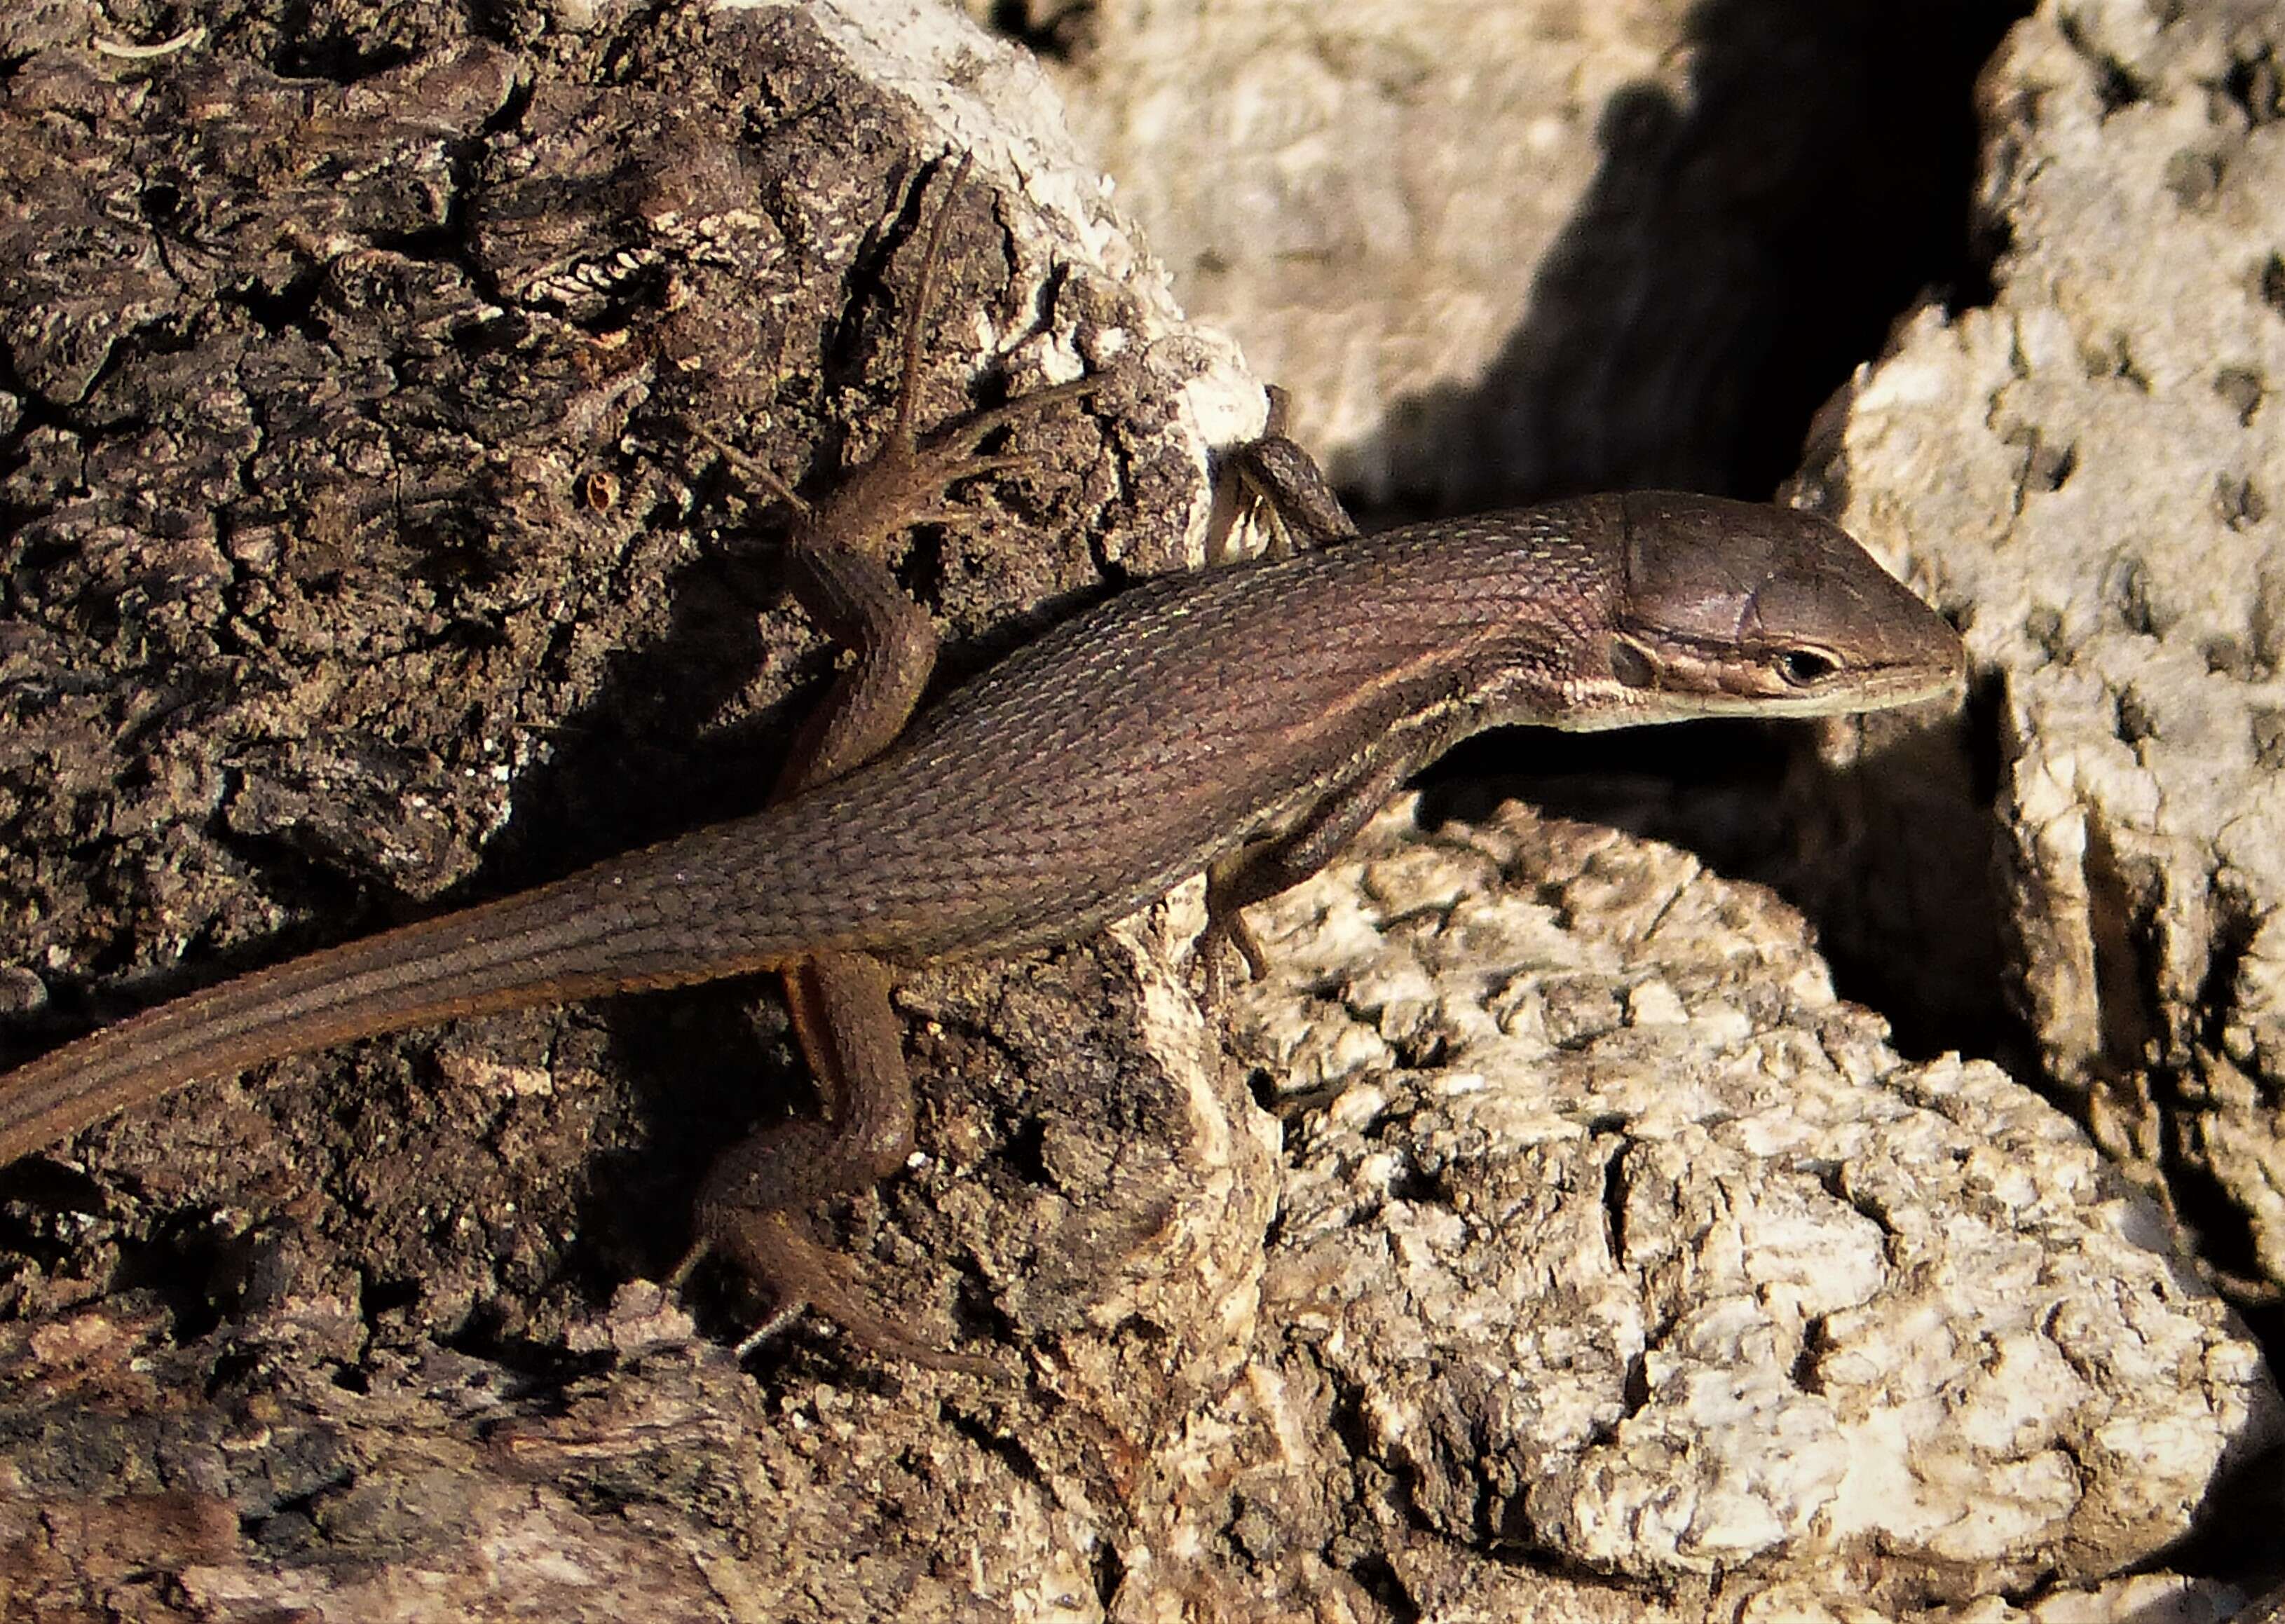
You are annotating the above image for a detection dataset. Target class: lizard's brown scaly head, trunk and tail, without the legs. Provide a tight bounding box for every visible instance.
[0,493,1960,1163]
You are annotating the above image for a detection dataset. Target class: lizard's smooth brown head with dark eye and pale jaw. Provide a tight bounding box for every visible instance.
[1602,491,1965,722]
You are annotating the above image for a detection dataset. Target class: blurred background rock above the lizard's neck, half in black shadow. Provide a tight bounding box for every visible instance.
[1037,0,2006,510]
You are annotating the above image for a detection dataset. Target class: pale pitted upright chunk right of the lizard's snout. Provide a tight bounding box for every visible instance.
[1823,2,2285,1292]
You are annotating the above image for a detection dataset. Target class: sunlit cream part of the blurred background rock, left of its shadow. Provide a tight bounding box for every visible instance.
[1037,0,1721,505]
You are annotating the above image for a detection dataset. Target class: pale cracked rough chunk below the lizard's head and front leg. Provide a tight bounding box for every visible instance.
[1241,806,2280,1601]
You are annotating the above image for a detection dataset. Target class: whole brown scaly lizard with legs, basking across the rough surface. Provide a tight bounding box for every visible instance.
[0,155,1963,1368]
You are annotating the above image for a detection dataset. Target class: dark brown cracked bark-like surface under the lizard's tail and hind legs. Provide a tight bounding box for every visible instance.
[0,7,1268,1617]
